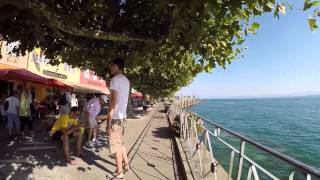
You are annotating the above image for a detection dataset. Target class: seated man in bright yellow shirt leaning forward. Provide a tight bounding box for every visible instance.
[51,107,84,165]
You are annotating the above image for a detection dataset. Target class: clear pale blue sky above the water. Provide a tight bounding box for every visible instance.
[177,0,320,98]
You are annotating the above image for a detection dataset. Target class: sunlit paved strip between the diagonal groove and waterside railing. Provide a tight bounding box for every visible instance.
[128,111,178,180]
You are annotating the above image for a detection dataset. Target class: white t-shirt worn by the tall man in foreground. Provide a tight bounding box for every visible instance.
[110,74,130,119]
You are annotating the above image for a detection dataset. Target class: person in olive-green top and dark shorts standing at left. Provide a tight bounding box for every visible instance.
[19,88,34,139]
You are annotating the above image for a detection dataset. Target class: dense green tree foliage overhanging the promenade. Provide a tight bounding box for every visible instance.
[0,0,320,96]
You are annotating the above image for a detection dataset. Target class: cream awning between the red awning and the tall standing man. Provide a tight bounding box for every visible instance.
[62,81,110,94]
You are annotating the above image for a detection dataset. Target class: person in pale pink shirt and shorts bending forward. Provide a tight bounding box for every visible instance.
[84,95,108,147]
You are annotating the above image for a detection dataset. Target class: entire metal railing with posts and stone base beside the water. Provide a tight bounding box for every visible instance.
[168,105,320,180]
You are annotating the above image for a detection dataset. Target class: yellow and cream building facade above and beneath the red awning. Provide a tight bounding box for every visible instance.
[0,41,109,101]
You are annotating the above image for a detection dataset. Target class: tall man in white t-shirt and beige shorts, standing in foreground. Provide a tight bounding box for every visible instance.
[106,58,130,179]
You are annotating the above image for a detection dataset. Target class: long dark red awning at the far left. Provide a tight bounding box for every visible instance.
[0,69,72,89]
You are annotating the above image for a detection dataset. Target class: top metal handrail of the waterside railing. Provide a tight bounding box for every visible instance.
[172,104,320,178]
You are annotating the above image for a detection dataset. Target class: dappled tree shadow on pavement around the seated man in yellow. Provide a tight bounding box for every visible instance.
[0,122,115,180]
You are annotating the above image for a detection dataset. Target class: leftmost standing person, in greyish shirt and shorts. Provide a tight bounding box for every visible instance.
[7,91,20,137]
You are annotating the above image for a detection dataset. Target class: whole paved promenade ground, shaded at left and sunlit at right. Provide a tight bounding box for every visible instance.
[0,106,177,180]
